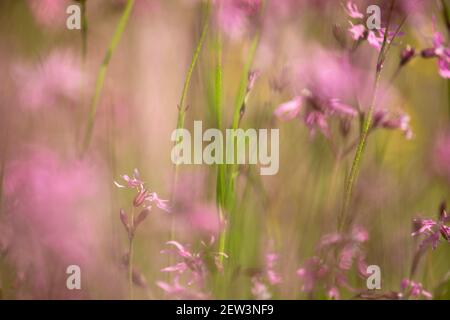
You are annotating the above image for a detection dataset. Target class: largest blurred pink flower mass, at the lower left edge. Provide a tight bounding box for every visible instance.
[0,148,109,298]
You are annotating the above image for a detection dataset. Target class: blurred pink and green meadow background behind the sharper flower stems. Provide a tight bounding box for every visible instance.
[0,0,450,299]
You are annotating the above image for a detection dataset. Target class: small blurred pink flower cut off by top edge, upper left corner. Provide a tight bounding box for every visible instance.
[28,0,67,28]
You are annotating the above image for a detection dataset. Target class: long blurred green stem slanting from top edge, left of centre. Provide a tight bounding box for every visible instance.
[82,0,134,154]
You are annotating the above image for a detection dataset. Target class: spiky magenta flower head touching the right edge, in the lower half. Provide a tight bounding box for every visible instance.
[411,203,450,250]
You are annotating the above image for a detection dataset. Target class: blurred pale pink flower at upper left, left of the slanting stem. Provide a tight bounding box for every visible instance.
[13,51,84,110]
